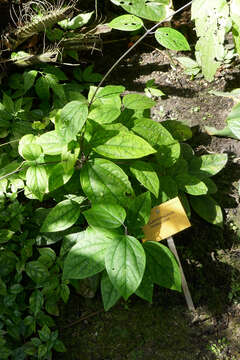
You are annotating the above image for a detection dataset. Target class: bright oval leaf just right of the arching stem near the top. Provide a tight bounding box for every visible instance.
[155,27,191,51]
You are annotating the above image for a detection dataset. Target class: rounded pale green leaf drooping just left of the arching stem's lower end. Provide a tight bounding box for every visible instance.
[55,100,88,142]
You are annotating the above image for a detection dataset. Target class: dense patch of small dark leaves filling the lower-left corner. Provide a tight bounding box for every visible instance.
[0,198,66,360]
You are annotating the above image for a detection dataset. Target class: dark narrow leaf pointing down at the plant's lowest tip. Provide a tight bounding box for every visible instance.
[101,271,121,311]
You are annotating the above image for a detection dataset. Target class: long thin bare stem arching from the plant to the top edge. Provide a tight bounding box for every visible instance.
[88,1,192,108]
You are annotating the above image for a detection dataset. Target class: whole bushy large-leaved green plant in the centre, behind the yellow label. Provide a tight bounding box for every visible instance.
[0,72,227,309]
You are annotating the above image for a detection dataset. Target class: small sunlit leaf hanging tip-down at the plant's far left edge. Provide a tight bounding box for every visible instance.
[26,165,48,201]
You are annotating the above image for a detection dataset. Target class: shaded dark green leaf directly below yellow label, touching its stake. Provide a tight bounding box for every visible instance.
[143,241,181,291]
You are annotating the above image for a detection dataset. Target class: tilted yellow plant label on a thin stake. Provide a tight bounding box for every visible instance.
[143,197,191,241]
